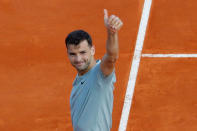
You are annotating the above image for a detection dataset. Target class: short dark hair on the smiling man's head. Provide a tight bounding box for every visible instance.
[65,30,92,48]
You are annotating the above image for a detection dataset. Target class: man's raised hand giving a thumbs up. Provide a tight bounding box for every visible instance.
[104,9,123,34]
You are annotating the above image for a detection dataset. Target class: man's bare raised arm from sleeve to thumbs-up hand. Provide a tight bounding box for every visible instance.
[101,9,123,76]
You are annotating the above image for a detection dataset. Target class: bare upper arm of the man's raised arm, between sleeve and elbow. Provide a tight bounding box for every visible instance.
[100,54,116,76]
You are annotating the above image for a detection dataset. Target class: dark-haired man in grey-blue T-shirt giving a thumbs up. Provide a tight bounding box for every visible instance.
[65,9,123,131]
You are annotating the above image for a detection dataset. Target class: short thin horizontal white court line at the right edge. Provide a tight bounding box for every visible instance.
[142,54,197,58]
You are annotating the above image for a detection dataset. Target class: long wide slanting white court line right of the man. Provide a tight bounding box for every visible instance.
[119,0,152,131]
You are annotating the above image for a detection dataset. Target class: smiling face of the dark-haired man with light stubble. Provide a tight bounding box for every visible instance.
[67,40,95,71]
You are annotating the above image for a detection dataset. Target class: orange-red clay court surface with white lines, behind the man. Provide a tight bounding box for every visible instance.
[0,0,197,131]
